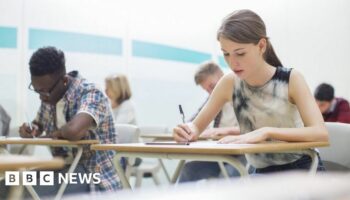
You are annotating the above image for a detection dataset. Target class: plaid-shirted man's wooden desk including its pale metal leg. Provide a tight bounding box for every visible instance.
[0,137,99,199]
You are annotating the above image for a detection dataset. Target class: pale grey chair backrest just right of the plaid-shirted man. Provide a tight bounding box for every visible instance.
[115,124,140,143]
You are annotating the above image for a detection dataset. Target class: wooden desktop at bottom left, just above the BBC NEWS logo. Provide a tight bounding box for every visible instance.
[0,155,64,171]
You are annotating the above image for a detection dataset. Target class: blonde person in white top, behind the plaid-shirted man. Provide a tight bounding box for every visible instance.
[105,74,137,125]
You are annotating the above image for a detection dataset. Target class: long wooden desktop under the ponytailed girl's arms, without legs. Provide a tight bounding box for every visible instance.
[91,141,329,155]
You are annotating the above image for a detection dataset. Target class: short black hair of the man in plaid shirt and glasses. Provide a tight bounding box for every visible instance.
[29,46,66,76]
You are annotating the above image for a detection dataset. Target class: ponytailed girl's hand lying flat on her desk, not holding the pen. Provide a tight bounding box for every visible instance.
[218,128,268,144]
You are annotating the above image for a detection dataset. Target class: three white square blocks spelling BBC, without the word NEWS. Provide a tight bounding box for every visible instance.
[5,171,54,186]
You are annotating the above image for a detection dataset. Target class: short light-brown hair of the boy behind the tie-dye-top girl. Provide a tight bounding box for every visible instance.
[194,61,222,85]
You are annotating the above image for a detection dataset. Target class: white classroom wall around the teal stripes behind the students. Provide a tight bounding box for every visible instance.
[0,0,350,130]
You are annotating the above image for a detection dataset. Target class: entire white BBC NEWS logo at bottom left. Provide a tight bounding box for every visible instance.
[5,171,101,186]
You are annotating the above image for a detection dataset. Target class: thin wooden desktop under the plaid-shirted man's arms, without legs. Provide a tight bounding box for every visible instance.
[0,137,99,145]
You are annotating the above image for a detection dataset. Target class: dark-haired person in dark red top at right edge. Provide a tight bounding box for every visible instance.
[314,83,350,124]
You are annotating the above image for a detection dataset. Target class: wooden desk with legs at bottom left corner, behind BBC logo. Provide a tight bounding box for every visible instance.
[0,155,64,199]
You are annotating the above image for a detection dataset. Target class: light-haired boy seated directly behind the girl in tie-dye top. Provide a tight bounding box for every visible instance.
[179,61,246,183]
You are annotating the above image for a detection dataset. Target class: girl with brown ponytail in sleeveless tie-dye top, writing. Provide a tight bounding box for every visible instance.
[173,10,328,173]
